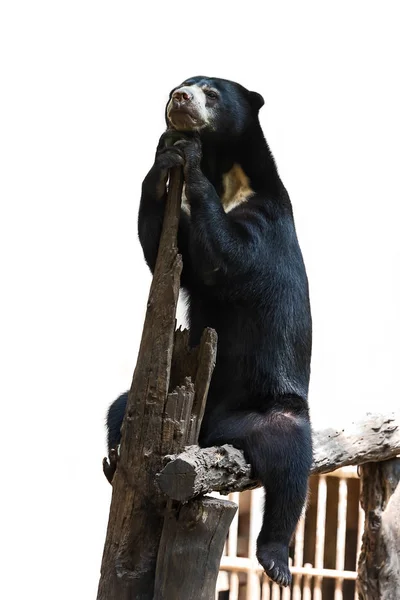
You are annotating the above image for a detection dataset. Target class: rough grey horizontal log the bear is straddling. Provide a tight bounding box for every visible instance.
[157,412,400,502]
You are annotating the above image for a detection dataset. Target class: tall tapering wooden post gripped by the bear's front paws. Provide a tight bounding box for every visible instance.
[97,169,183,600]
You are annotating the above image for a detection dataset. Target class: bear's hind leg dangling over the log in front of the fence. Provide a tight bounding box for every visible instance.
[201,408,312,586]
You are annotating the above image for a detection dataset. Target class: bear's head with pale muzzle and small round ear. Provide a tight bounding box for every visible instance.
[166,76,264,136]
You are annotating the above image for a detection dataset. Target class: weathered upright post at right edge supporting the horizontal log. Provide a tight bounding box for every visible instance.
[357,458,400,600]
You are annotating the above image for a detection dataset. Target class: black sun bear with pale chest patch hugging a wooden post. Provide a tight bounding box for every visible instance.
[104,76,312,586]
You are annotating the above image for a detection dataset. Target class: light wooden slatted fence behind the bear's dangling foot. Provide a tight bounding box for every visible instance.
[216,467,364,600]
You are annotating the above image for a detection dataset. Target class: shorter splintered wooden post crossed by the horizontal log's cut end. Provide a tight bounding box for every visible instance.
[154,329,237,600]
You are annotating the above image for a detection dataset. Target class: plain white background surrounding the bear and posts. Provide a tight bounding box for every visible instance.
[0,0,400,600]
